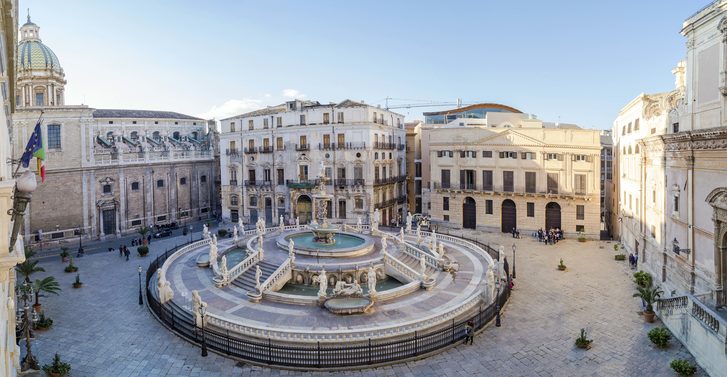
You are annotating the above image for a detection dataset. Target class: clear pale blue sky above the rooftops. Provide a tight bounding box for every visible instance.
[20,0,708,128]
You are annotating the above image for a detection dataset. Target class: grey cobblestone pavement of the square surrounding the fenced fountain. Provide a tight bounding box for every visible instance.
[21,232,704,377]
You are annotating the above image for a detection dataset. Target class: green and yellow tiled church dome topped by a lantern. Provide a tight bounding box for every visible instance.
[17,16,63,74]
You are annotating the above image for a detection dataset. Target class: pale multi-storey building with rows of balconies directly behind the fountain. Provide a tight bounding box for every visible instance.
[220,100,406,225]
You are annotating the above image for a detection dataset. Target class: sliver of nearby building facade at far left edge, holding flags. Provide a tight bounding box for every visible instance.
[0,0,25,377]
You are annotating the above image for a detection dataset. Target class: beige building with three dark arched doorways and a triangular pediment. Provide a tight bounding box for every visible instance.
[422,104,601,238]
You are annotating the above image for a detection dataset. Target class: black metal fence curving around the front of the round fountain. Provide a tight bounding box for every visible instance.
[146,238,510,369]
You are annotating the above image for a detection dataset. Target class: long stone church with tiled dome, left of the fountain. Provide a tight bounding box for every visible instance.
[13,17,215,246]
